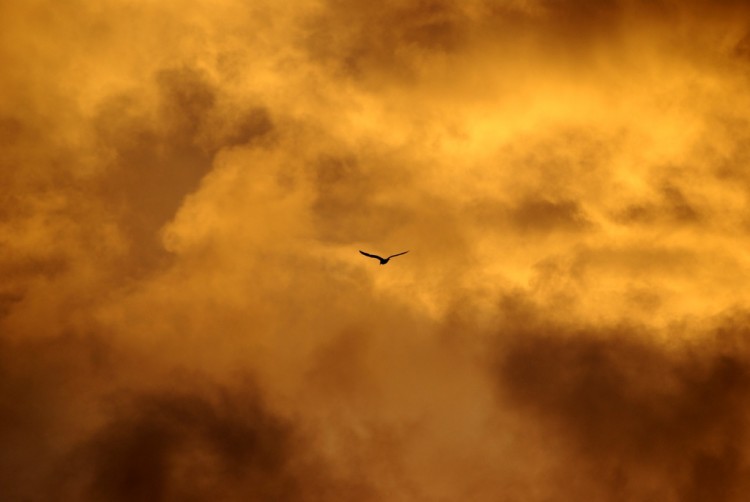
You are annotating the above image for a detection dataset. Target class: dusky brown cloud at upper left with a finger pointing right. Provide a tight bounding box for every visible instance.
[95,67,272,274]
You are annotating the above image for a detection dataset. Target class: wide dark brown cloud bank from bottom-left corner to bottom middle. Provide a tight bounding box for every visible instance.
[0,335,373,501]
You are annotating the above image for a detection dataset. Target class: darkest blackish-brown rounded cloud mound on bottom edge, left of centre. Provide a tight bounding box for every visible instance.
[64,389,347,501]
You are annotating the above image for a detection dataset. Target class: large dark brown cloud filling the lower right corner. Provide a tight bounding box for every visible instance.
[495,301,750,501]
